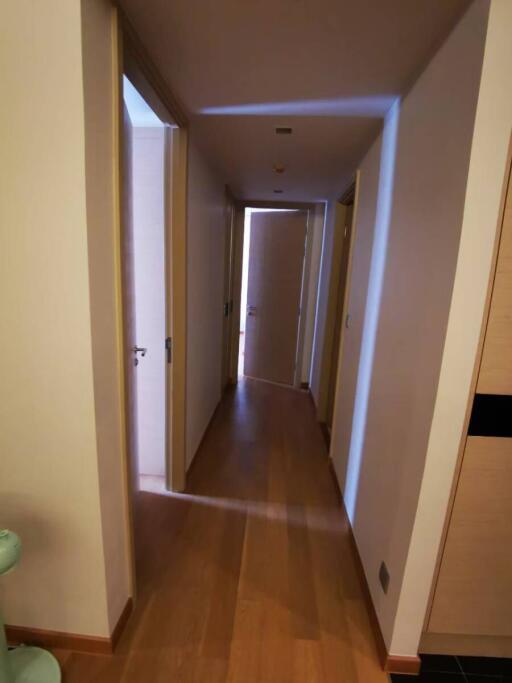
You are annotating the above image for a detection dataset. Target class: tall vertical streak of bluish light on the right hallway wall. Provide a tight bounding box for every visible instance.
[344,99,400,524]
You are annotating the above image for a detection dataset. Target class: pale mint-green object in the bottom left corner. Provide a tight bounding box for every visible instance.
[0,529,61,683]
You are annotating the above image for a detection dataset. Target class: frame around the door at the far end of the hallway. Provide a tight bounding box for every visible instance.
[228,199,315,389]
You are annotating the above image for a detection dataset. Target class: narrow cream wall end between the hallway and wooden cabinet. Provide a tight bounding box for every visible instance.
[391,0,512,654]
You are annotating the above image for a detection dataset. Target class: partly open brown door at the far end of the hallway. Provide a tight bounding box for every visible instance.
[244,211,307,385]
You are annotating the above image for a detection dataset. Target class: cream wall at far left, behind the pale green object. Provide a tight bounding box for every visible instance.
[0,0,116,636]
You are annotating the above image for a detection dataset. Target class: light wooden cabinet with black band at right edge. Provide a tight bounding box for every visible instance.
[422,158,512,657]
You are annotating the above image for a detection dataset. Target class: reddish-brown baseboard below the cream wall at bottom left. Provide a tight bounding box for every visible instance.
[5,598,133,655]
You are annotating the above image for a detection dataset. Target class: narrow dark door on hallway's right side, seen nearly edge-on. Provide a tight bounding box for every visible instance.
[326,204,354,431]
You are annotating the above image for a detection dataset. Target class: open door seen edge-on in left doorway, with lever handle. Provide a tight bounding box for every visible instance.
[121,105,139,492]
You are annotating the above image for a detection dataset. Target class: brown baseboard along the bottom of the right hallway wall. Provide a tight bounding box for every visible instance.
[329,458,421,675]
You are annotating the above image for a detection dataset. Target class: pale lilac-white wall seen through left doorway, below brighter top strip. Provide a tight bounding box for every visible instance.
[132,126,166,476]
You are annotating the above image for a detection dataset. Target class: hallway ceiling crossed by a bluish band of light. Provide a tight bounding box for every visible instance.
[121,0,470,201]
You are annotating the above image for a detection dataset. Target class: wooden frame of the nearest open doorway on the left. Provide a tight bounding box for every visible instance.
[112,6,188,596]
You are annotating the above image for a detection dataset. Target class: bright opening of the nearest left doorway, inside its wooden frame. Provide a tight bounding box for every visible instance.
[123,76,170,490]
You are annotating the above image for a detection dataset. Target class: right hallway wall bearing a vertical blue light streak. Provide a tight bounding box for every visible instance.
[332,0,487,654]
